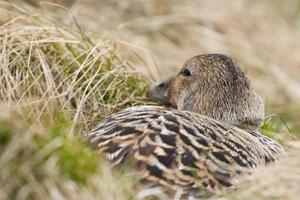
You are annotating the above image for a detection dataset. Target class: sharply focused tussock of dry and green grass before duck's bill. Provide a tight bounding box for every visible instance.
[0,3,147,134]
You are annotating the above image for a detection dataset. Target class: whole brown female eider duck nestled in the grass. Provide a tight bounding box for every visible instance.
[87,54,286,191]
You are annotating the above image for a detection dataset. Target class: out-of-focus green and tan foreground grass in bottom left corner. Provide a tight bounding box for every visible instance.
[0,108,142,199]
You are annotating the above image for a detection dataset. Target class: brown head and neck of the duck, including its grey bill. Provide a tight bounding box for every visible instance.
[149,54,264,130]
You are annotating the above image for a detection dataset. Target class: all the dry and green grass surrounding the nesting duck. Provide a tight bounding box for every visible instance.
[0,0,300,199]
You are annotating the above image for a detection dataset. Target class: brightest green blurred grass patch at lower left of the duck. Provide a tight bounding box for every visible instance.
[33,112,100,184]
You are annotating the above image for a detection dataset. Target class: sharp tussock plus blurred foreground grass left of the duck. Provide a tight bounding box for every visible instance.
[0,2,148,199]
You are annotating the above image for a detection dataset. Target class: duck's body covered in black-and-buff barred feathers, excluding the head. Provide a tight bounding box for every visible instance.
[86,106,286,190]
